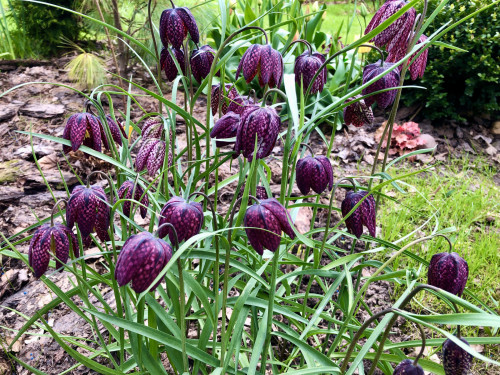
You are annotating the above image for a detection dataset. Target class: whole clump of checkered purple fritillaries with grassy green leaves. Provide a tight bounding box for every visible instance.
[1,0,500,375]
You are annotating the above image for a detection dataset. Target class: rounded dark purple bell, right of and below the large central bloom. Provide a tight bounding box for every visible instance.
[296,155,333,195]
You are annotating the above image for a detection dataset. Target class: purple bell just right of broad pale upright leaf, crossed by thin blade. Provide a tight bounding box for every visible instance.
[294,51,328,94]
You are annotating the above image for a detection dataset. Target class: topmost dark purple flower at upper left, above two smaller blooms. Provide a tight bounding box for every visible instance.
[160,7,200,48]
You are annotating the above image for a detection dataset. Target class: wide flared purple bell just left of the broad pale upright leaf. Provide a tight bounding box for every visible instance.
[236,44,283,88]
